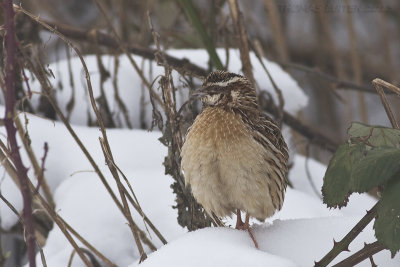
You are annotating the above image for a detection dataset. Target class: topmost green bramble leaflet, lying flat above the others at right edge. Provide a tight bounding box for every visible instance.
[348,122,400,148]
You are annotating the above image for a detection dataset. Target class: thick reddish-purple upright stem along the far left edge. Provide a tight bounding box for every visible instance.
[3,0,36,267]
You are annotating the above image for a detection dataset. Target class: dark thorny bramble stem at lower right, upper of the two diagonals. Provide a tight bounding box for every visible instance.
[314,202,379,267]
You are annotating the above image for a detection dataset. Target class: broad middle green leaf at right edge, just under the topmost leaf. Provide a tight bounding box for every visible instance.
[350,147,400,193]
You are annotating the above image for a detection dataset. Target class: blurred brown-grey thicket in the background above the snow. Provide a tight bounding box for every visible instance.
[0,0,400,266]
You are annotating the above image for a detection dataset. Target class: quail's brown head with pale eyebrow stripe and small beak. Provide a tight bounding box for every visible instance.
[195,70,258,110]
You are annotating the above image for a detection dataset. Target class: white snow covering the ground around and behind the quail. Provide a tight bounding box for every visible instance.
[0,50,400,267]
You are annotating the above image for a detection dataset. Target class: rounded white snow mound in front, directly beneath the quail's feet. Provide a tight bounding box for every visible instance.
[129,228,299,267]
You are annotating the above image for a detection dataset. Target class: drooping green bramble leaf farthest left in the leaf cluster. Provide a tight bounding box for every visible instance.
[322,143,365,208]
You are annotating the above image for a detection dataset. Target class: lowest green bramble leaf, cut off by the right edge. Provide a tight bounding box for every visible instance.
[374,176,400,254]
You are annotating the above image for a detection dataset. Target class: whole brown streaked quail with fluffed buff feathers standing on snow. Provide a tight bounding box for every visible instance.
[181,71,289,248]
